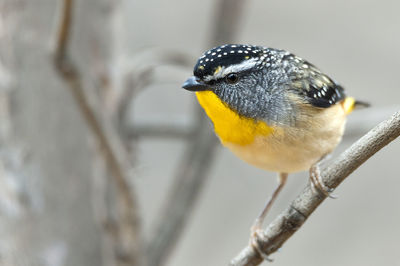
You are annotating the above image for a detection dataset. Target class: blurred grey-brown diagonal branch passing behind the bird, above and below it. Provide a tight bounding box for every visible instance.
[148,0,247,266]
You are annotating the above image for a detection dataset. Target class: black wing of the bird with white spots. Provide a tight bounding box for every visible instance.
[286,55,345,108]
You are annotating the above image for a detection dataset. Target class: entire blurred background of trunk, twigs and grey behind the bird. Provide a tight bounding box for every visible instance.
[0,0,400,266]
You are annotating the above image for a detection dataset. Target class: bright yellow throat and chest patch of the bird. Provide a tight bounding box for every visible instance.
[196,91,273,145]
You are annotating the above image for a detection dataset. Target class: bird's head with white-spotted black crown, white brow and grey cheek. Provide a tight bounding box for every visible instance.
[182,44,283,119]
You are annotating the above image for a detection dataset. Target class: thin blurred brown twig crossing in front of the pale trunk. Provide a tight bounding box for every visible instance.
[54,0,141,265]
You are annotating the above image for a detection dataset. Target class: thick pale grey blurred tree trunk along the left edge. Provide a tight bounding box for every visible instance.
[0,0,139,266]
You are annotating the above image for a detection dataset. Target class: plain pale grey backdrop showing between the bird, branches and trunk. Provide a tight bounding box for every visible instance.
[126,0,400,266]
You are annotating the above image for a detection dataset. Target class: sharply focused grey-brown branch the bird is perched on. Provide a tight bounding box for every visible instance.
[230,111,400,266]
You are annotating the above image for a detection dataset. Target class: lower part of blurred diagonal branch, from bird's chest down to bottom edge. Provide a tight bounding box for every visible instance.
[148,113,218,265]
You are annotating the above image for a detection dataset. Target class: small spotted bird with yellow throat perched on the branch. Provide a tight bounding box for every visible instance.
[182,44,367,256]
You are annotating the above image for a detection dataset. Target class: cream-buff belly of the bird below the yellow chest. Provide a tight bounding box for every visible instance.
[224,104,346,173]
